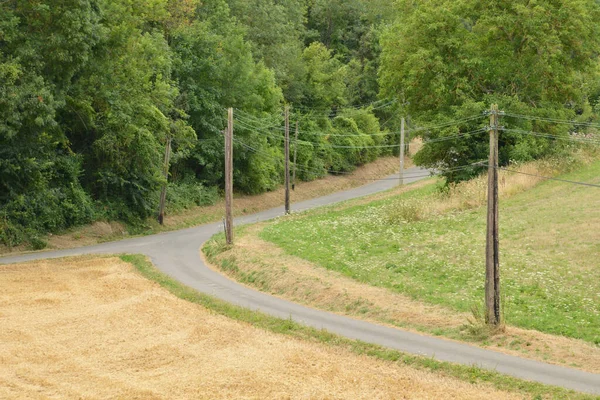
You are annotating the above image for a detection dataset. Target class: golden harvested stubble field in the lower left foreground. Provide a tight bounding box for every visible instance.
[0,258,520,399]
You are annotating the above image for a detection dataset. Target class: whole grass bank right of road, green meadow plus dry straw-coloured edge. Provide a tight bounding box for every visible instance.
[204,152,600,372]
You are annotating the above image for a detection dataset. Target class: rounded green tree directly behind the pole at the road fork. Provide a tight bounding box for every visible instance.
[172,1,282,192]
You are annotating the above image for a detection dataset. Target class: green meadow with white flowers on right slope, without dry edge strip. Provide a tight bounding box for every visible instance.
[261,162,600,344]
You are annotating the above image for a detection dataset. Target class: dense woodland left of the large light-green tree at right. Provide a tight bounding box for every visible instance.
[0,0,394,247]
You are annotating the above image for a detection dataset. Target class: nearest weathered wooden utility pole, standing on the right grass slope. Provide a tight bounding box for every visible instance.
[485,104,500,326]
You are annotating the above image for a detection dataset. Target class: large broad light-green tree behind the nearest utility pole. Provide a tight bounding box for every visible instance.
[380,0,600,178]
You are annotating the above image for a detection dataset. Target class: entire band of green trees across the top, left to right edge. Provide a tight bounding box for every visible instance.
[0,0,600,246]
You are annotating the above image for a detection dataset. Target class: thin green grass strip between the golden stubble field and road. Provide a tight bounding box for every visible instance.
[121,255,597,399]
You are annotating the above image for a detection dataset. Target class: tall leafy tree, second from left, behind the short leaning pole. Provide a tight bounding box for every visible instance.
[62,1,192,220]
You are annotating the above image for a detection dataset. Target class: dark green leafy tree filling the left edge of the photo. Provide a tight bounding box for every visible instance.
[0,0,98,244]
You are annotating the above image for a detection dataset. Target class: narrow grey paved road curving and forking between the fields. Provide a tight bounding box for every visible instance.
[0,168,600,395]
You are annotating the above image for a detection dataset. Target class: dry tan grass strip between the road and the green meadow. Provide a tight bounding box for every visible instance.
[205,228,600,373]
